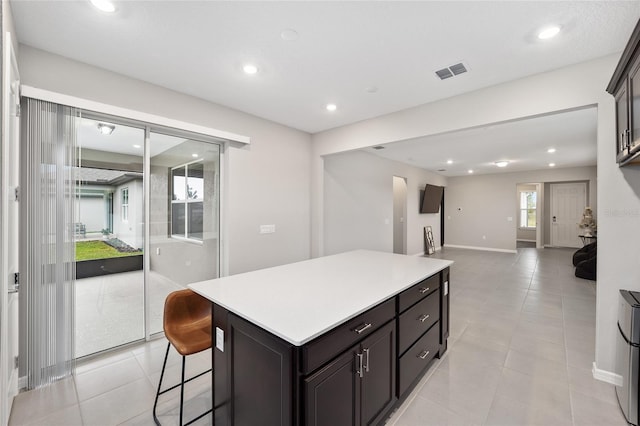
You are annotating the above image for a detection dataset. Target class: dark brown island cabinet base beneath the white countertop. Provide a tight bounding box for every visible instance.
[212,268,449,426]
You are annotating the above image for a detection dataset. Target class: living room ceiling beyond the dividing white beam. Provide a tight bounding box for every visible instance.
[365,107,597,176]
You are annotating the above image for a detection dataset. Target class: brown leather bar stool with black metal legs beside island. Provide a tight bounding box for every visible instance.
[153,289,213,426]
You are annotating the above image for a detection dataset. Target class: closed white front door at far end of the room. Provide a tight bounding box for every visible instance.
[551,182,587,248]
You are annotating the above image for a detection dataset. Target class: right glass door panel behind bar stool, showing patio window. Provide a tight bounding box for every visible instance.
[147,132,220,333]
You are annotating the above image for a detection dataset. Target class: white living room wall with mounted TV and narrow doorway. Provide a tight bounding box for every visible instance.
[324,151,447,255]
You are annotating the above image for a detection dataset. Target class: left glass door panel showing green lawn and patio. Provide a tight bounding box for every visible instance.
[73,116,145,358]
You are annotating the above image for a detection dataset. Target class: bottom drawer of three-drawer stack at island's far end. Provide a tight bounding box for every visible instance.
[398,324,440,397]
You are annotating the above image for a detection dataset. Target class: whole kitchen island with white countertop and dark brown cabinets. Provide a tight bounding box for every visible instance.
[189,250,453,426]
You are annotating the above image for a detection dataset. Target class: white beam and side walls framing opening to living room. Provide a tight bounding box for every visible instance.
[311,55,624,371]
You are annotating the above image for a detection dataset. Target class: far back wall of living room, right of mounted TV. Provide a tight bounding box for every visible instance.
[445,166,597,250]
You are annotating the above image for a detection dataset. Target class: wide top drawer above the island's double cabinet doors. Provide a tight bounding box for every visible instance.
[302,298,396,374]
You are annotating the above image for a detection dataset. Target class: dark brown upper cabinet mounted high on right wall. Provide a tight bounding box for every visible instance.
[607,21,640,166]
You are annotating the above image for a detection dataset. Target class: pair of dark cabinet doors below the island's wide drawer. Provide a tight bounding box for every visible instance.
[303,321,396,426]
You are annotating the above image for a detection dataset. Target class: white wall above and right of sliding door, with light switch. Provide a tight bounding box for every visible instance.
[18,45,311,274]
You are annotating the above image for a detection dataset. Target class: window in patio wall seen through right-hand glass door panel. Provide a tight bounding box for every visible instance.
[169,160,204,241]
